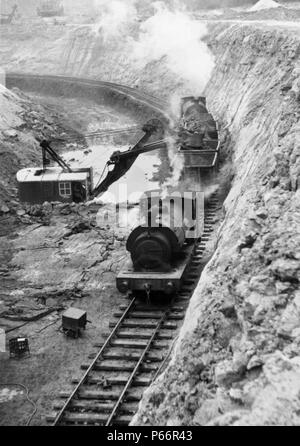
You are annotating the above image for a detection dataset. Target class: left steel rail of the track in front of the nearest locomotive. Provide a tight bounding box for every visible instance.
[53,297,136,426]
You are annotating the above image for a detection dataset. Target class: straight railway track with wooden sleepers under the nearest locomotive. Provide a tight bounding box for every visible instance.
[47,195,219,426]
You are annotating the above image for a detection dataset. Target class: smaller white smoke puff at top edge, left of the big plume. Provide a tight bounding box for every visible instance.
[93,0,137,42]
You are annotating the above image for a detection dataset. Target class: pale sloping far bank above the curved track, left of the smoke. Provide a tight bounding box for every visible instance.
[0,22,197,99]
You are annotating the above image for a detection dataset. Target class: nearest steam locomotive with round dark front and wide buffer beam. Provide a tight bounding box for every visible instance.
[117,192,203,294]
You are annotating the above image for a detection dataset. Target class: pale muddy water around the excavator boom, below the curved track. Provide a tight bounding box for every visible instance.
[27,94,162,203]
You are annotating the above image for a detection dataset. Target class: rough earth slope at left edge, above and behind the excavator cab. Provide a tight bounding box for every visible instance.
[0,85,81,206]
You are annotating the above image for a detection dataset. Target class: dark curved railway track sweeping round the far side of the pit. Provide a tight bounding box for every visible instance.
[6,72,174,120]
